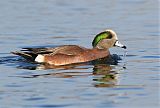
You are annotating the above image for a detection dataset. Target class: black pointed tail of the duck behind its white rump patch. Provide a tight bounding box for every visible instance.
[11,51,38,61]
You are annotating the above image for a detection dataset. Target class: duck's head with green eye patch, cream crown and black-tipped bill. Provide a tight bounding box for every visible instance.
[92,29,127,49]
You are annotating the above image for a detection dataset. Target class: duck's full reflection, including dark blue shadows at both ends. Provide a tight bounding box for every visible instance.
[1,55,120,87]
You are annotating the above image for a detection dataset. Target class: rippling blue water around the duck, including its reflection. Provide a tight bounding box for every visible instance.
[0,0,160,108]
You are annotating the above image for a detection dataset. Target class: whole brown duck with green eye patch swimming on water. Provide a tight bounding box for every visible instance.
[11,29,127,66]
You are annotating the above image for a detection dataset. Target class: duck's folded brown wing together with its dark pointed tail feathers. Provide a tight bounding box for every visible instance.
[11,45,86,61]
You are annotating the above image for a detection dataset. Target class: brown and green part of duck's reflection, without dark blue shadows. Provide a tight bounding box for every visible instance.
[19,64,118,87]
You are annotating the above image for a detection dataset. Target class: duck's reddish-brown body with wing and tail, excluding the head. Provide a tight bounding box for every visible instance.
[13,45,110,65]
